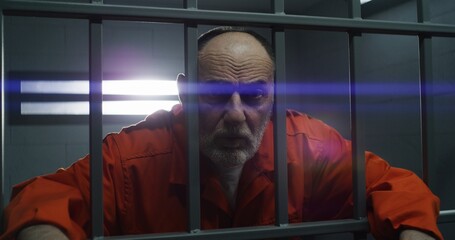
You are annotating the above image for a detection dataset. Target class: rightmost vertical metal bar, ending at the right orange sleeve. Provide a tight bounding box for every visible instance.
[417,0,435,184]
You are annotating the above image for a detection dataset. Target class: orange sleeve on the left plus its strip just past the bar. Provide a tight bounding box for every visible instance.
[0,134,121,240]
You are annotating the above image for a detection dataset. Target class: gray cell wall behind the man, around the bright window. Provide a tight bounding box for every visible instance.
[1,0,455,239]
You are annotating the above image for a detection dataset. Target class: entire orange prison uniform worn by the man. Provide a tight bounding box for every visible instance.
[1,105,442,239]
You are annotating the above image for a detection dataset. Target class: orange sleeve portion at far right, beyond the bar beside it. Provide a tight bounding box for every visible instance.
[366,152,443,239]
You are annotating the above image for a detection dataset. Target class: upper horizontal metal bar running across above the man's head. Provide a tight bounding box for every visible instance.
[0,0,455,37]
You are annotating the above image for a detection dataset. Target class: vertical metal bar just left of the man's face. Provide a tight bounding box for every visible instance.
[184,0,201,233]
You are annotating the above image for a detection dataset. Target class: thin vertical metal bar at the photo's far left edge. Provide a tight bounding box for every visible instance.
[0,8,6,232]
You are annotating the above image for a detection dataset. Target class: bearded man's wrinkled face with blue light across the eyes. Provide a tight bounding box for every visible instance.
[198,32,274,167]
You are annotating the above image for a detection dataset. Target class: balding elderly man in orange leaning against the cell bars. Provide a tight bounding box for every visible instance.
[2,27,442,240]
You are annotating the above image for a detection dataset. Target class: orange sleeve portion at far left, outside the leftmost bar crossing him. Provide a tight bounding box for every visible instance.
[1,160,89,239]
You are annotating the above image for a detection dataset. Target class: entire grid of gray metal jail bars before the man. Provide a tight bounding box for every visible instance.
[0,0,455,239]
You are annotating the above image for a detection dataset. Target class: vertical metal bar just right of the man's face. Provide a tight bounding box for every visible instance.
[273,0,289,226]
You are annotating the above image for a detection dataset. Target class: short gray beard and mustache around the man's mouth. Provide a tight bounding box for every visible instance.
[199,111,272,167]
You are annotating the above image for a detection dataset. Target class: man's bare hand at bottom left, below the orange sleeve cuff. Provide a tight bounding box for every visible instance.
[17,224,69,240]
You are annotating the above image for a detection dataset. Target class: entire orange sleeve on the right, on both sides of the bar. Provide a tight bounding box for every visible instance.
[310,125,443,239]
